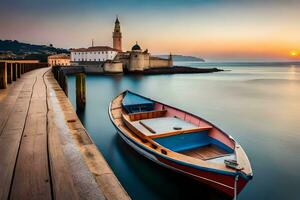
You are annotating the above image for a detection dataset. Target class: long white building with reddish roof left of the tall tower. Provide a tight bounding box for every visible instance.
[70,46,118,62]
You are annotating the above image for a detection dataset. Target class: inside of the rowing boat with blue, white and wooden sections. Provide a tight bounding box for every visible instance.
[118,91,235,163]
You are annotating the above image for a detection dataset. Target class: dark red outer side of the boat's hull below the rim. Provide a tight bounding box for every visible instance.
[115,126,248,197]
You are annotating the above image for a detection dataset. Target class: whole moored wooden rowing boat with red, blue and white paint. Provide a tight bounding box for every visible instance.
[109,91,253,197]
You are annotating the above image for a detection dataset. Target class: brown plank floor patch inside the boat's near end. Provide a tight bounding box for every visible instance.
[180,145,227,160]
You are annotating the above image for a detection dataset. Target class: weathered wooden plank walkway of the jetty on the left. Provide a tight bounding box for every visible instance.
[0,68,130,200]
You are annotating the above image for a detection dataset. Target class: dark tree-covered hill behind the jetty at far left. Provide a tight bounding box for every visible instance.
[0,40,69,61]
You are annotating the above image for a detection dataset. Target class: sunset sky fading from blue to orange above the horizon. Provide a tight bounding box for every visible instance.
[0,0,300,60]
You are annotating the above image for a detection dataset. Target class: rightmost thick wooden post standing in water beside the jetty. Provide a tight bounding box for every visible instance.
[76,73,86,109]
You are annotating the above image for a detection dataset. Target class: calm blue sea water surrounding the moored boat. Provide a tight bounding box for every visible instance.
[68,63,300,200]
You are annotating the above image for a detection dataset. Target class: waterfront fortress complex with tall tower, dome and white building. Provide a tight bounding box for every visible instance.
[70,17,173,73]
